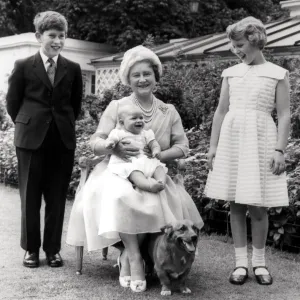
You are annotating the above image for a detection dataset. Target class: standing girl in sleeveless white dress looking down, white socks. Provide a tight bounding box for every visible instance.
[205,17,290,285]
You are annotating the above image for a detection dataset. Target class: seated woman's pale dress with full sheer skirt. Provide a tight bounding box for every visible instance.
[66,96,203,251]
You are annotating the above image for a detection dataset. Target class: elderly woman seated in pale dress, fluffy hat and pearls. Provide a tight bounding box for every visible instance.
[67,46,203,292]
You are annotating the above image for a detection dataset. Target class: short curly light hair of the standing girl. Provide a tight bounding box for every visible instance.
[226,17,267,50]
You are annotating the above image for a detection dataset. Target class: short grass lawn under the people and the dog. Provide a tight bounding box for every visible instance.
[0,184,300,300]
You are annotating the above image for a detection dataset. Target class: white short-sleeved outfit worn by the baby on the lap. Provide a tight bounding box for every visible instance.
[108,128,168,179]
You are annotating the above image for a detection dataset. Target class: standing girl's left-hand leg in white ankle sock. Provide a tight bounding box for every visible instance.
[230,202,248,278]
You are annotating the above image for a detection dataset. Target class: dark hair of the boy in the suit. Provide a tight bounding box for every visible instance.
[33,10,68,34]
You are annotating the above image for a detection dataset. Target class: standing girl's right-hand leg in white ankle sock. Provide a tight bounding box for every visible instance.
[249,206,269,275]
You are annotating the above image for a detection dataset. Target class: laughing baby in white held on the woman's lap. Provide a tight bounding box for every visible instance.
[105,105,168,193]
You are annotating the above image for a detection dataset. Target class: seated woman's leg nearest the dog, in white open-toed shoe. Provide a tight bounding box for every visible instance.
[120,233,146,292]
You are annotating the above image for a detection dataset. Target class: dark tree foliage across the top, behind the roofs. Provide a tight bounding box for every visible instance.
[0,0,287,50]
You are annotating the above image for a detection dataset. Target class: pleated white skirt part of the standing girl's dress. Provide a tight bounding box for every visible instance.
[204,109,289,207]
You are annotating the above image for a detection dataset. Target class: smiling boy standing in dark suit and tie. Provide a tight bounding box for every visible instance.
[6,11,82,268]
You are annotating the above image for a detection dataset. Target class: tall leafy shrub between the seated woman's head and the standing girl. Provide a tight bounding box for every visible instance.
[156,59,234,131]
